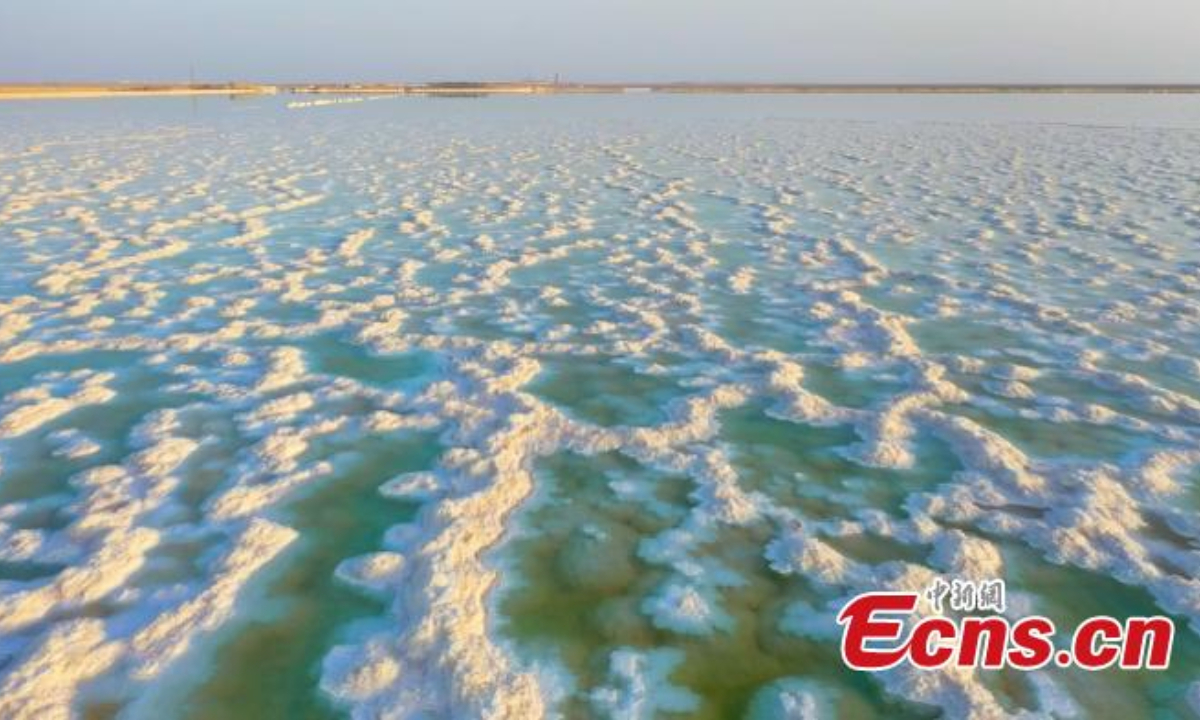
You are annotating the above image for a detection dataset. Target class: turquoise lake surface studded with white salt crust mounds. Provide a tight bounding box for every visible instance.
[0,100,1200,720]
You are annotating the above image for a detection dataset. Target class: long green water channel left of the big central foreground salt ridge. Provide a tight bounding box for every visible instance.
[181,436,440,720]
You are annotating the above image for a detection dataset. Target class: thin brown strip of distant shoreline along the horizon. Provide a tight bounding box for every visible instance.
[0,82,1200,100]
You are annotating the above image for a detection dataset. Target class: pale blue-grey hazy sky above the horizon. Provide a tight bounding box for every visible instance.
[0,0,1200,83]
